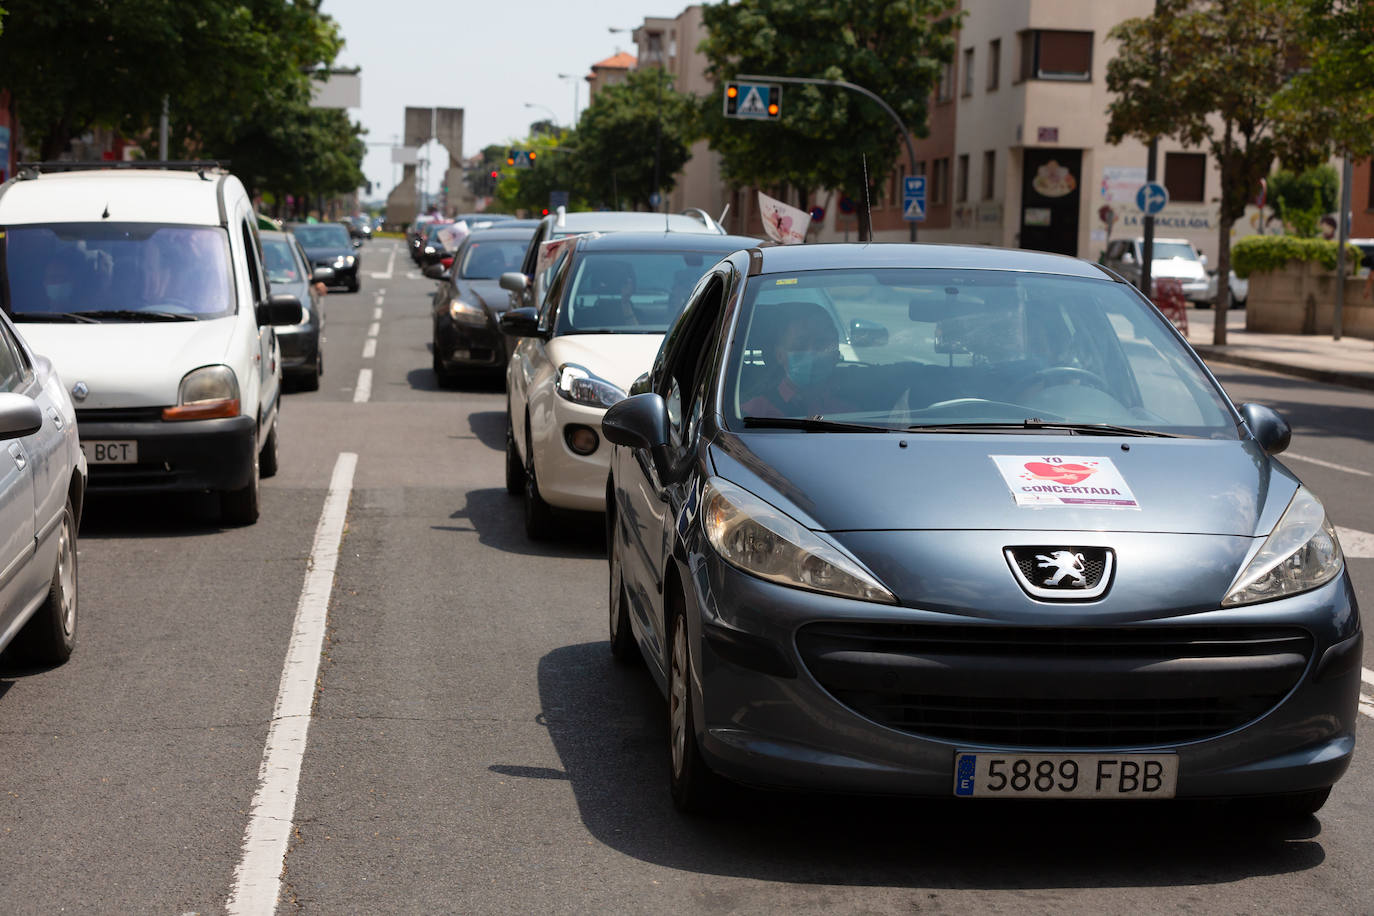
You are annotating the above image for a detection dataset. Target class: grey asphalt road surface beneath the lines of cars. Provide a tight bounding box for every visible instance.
[0,240,1374,913]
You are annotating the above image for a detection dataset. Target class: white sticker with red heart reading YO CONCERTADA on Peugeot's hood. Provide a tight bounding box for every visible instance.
[988,455,1140,509]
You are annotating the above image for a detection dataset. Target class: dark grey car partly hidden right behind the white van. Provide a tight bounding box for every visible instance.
[258,232,334,391]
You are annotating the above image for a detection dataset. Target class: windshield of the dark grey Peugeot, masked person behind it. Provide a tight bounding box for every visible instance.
[723,269,1239,438]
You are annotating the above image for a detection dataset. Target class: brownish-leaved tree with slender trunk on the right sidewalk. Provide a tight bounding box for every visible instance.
[1107,0,1308,345]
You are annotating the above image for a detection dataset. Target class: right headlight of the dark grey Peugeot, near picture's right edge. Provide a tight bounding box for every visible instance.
[1221,486,1345,607]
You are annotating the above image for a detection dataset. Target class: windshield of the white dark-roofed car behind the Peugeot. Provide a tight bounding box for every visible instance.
[555,251,724,335]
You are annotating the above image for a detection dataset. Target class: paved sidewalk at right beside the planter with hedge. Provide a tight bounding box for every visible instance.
[1187,309,1374,390]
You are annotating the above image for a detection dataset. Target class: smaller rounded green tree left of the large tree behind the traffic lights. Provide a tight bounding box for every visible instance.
[566,67,701,209]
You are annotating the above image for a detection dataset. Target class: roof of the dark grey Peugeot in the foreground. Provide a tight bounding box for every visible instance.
[750,242,1116,280]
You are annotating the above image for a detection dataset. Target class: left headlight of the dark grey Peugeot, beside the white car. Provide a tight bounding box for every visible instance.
[701,478,897,604]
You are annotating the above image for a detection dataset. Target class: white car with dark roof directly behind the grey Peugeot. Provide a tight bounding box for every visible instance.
[500,229,758,538]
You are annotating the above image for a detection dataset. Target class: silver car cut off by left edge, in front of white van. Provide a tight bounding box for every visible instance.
[0,311,87,665]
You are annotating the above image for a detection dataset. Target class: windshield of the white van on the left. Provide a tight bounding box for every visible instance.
[0,222,234,321]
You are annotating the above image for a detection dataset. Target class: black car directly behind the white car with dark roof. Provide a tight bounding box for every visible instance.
[425,220,534,387]
